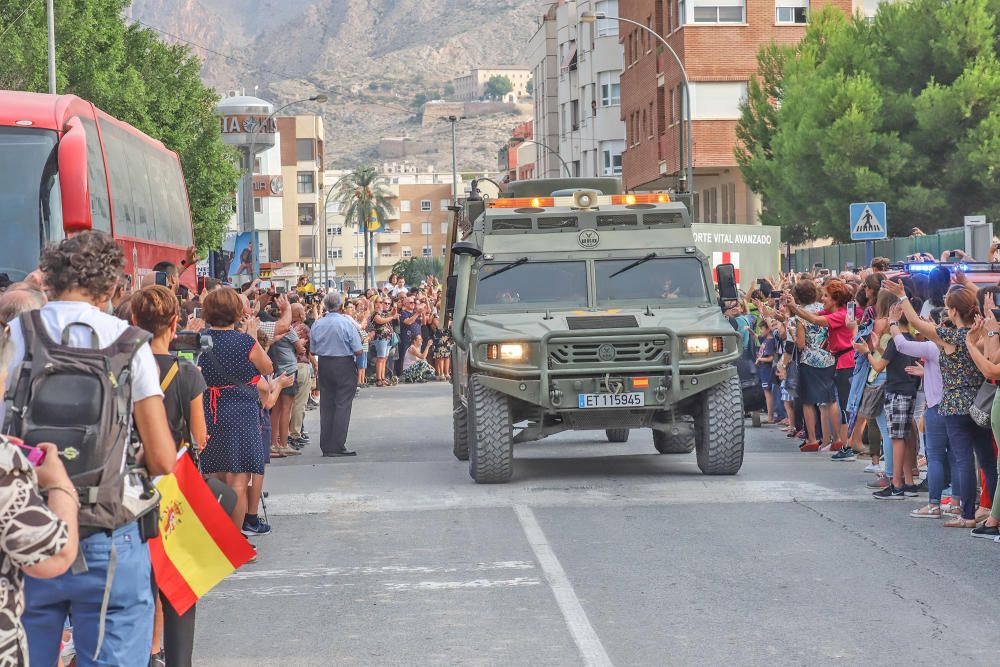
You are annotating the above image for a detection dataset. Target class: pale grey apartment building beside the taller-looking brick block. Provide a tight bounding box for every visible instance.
[528,0,627,177]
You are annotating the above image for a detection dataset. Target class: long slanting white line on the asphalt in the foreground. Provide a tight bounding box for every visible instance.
[514,505,612,667]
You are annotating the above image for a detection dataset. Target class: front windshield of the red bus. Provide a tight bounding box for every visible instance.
[0,127,62,282]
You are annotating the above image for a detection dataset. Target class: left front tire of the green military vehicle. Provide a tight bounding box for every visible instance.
[466,375,514,484]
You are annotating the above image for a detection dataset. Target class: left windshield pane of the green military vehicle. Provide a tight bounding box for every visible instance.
[476,261,587,310]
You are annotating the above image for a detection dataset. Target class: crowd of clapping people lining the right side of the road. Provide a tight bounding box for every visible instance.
[726,251,1000,541]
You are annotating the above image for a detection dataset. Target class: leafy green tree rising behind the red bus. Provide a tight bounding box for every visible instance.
[0,0,239,250]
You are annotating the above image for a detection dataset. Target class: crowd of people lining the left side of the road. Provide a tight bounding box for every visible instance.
[0,232,451,666]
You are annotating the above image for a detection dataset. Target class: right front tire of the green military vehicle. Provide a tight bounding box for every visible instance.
[694,375,745,475]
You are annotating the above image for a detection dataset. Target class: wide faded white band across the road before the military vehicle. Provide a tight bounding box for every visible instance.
[267,477,869,516]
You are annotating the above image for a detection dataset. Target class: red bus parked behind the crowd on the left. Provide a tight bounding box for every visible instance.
[0,91,194,281]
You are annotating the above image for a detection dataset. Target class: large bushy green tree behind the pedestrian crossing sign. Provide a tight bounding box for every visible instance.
[736,0,1000,240]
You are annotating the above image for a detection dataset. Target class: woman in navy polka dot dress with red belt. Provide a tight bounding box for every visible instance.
[199,287,273,527]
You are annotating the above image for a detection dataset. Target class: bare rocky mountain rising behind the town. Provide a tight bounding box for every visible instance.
[128,0,545,170]
